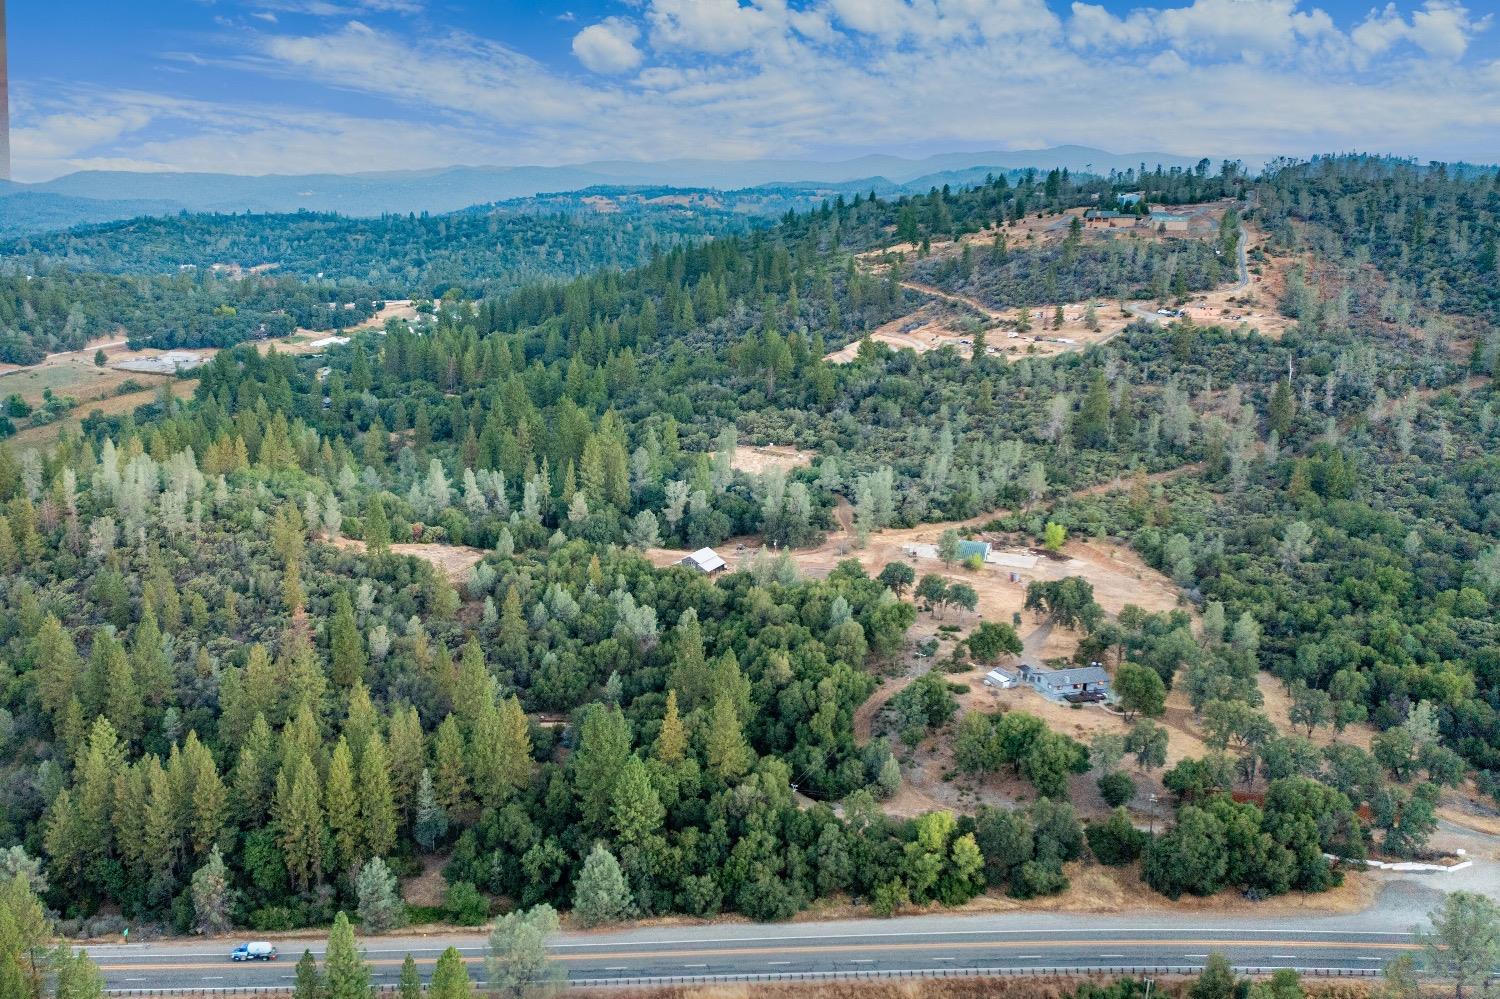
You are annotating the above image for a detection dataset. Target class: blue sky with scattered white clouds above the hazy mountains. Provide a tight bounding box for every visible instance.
[9,0,1500,180]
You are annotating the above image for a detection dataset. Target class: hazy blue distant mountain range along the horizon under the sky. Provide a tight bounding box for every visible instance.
[0,146,1242,236]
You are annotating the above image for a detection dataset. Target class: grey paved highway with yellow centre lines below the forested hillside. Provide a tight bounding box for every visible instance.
[90,914,1415,992]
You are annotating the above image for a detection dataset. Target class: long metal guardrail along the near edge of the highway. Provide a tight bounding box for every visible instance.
[105,965,1382,999]
